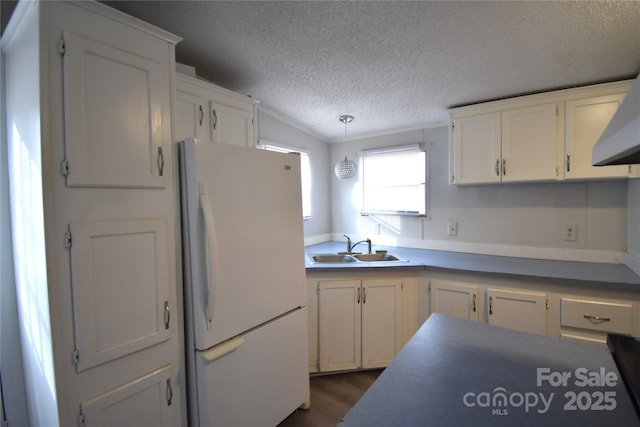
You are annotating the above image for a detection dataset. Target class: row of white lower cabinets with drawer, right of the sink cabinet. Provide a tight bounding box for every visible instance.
[416,270,640,345]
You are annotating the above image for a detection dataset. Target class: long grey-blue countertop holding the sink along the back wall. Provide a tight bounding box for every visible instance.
[305,242,640,291]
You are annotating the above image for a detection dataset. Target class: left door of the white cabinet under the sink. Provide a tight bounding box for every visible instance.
[318,280,362,371]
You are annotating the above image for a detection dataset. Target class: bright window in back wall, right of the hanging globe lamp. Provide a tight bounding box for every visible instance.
[362,144,427,216]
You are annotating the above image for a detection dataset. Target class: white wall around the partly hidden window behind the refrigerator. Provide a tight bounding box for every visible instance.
[258,109,331,245]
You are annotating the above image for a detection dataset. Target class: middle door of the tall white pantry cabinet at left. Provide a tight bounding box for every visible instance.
[70,219,170,371]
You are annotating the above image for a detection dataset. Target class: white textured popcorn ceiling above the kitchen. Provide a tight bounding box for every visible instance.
[38,1,640,141]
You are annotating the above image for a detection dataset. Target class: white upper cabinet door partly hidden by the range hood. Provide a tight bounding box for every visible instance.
[565,94,629,179]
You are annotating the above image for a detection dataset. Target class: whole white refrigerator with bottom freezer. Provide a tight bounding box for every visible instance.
[179,139,309,427]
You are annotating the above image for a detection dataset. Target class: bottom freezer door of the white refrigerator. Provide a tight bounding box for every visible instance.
[192,307,309,427]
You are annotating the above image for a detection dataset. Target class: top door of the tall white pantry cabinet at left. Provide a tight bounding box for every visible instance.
[63,32,168,188]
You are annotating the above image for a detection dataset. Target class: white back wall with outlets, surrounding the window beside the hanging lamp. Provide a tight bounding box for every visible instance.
[331,126,637,262]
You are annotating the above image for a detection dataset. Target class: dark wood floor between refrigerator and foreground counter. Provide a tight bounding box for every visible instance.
[278,369,382,427]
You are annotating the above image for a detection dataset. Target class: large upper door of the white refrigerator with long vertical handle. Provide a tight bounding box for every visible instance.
[180,140,306,350]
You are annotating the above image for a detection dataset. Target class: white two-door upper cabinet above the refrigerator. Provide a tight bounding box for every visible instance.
[175,74,257,147]
